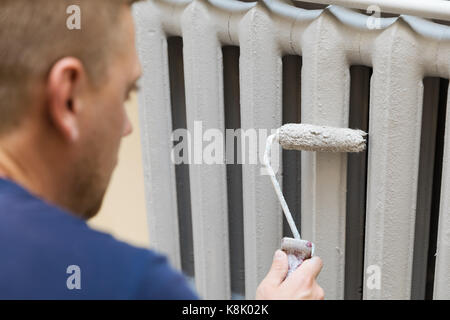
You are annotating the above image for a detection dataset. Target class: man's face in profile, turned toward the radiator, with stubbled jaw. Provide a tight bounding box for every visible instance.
[71,9,141,219]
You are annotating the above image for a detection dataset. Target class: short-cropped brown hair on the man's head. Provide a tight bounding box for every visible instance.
[0,0,142,134]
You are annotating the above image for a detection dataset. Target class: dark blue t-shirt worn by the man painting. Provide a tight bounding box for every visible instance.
[0,179,198,300]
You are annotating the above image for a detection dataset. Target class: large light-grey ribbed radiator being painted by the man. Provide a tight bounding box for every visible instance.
[134,0,450,299]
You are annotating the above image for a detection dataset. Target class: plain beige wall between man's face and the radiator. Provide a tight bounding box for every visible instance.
[89,95,149,247]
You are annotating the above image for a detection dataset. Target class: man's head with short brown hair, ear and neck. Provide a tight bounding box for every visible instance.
[0,0,141,218]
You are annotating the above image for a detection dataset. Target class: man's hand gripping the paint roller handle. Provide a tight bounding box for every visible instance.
[256,250,324,300]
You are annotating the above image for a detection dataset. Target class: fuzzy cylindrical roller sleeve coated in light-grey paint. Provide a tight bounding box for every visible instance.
[278,123,367,152]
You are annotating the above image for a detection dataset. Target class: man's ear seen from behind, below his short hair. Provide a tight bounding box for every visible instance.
[47,57,85,142]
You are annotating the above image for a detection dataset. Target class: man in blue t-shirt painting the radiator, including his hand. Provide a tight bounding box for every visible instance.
[0,0,323,299]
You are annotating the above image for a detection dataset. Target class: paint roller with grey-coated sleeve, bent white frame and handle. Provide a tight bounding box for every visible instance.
[264,123,367,276]
